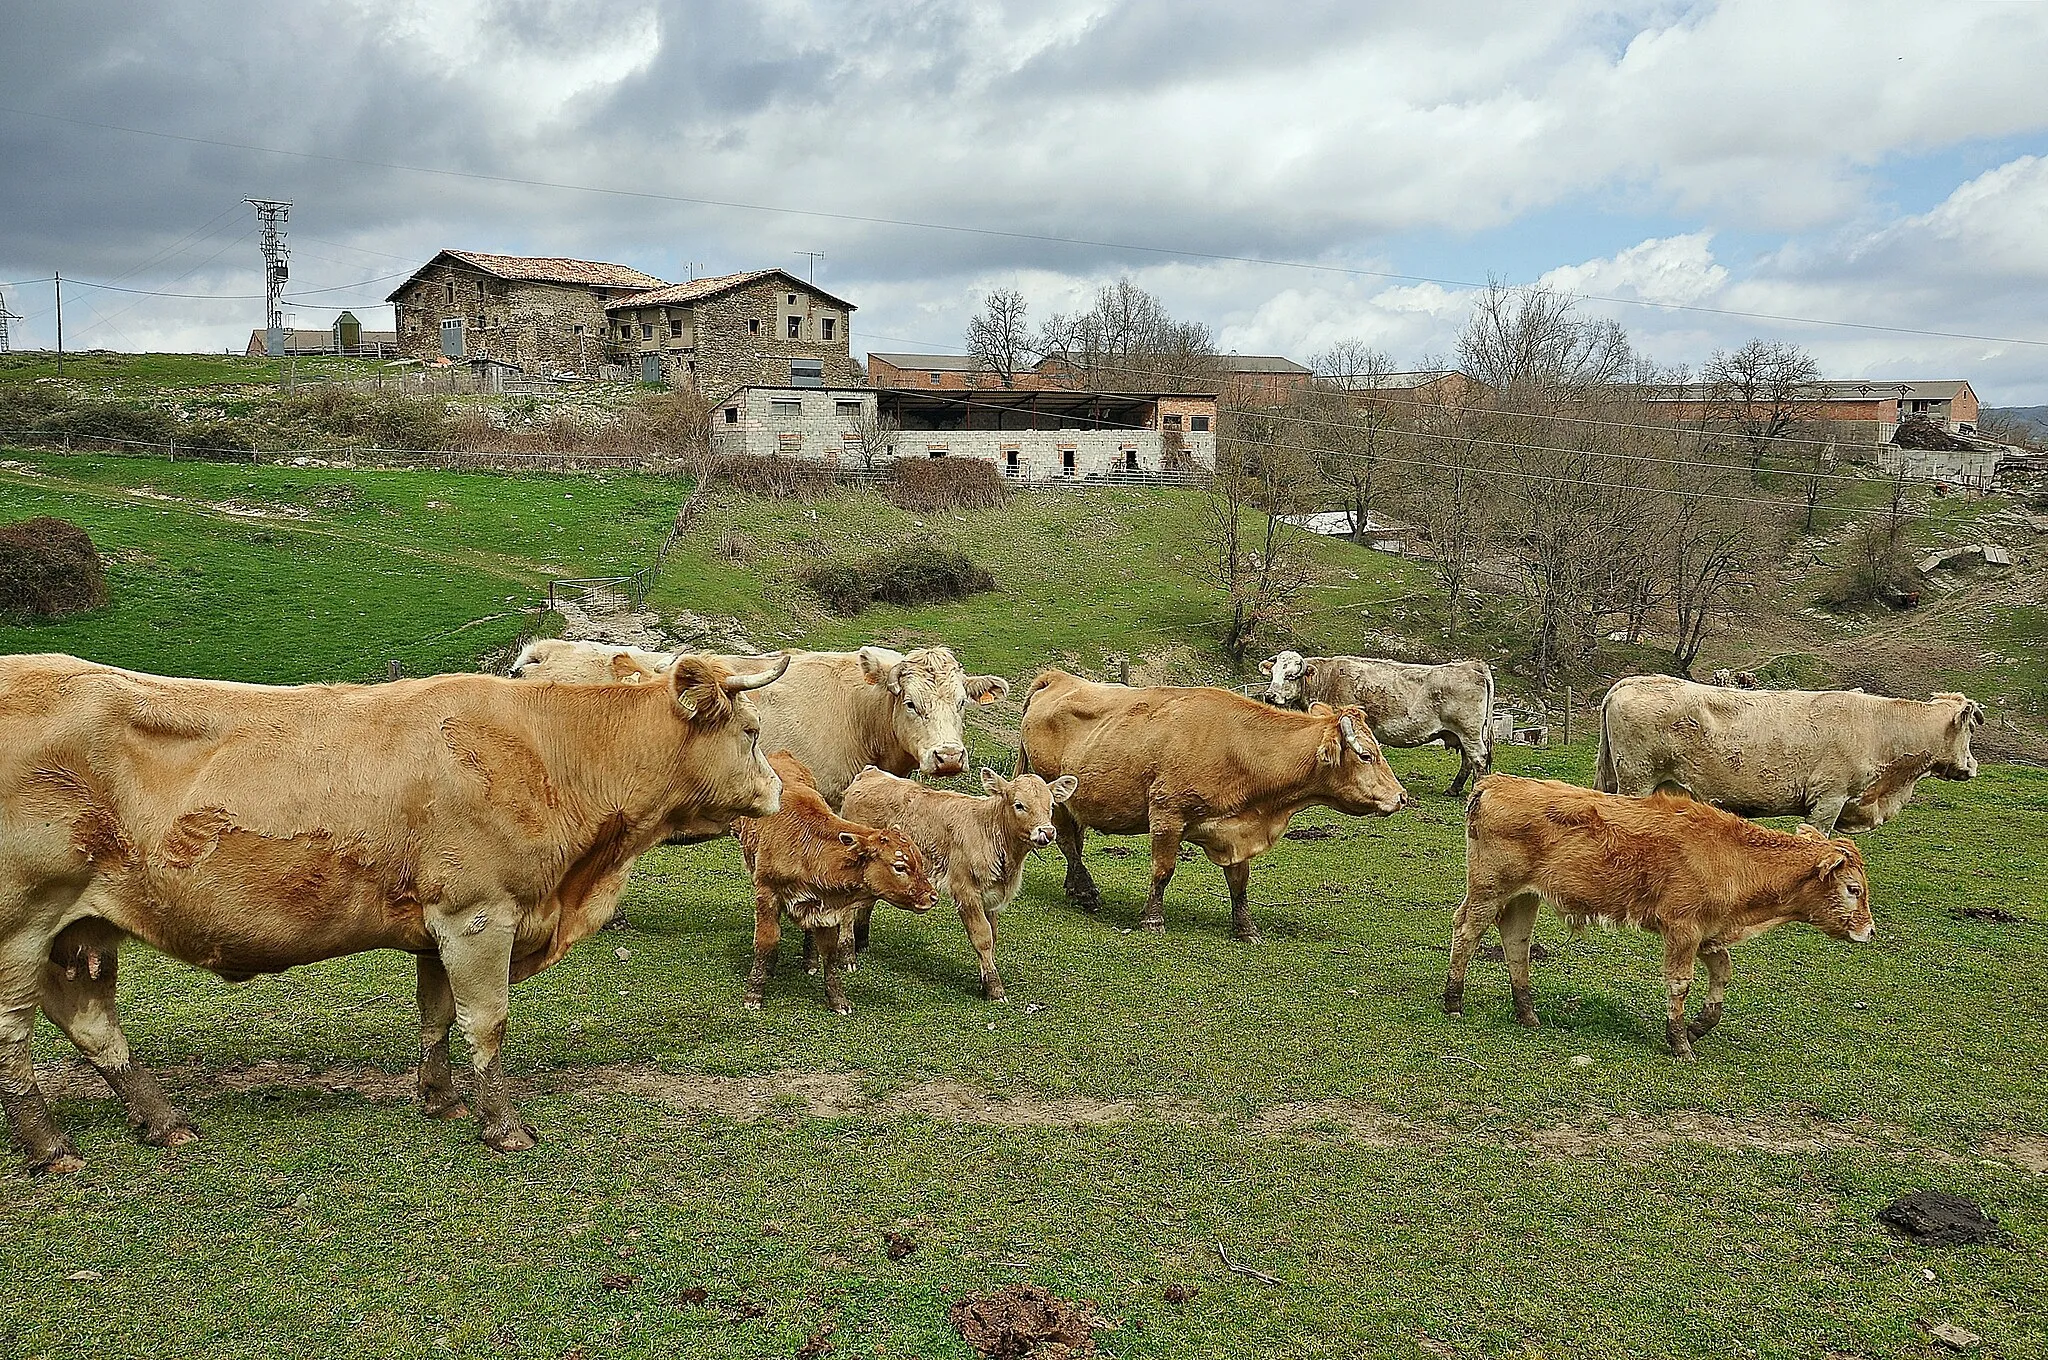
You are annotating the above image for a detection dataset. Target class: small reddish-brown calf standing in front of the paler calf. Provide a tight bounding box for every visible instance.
[733,752,938,1016]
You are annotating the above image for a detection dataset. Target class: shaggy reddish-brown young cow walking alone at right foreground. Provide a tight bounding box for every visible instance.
[1444,774,1878,1059]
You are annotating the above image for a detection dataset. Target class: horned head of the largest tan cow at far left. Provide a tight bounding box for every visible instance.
[662,653,788,840]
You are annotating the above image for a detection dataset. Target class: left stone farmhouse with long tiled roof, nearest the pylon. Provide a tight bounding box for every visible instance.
[385,250,668,377]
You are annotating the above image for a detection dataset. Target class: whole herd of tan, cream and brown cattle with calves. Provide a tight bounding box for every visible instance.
[0,641,1982,1170]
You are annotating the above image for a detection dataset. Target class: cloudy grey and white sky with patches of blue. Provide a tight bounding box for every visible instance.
[0,0,2048,406]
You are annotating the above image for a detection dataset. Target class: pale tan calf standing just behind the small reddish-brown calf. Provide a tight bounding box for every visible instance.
[842,768,1075,1002]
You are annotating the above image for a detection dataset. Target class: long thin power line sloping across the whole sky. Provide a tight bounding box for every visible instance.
[16,107,2048,348]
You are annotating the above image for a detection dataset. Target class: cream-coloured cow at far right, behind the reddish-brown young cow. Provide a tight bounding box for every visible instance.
[1595,676,1985,834]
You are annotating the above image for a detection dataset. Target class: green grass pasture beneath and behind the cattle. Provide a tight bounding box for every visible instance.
[0,440,2048,1360]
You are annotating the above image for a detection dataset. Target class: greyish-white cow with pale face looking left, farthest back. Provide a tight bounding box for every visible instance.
[1260,651,1493,793]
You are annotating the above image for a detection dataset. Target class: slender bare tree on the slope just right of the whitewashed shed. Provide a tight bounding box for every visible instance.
[1204,410,1317,666]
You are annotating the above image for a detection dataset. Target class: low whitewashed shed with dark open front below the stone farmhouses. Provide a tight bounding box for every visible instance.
[711,385,1217,481]
